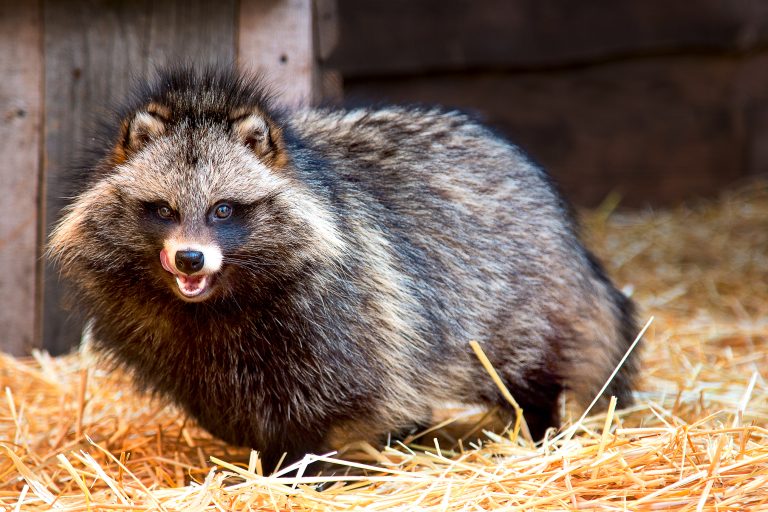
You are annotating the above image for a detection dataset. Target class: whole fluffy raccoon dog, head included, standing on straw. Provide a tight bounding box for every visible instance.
[51,69,635,472]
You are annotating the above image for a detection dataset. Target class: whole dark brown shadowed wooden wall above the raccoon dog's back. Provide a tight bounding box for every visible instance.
[330,0,768,206]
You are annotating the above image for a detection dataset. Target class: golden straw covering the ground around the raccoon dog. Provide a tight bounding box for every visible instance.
[0,184,768,511]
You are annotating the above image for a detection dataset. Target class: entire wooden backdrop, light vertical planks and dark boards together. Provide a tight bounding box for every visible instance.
[0,0,768,354]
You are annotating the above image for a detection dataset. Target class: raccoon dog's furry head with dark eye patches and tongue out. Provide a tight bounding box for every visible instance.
[50,70,341,302]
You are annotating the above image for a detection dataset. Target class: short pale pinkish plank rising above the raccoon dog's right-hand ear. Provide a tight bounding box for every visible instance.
[237,0,320,106]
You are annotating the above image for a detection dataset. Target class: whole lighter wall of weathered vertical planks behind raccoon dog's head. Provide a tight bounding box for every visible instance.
[0,0,333,354]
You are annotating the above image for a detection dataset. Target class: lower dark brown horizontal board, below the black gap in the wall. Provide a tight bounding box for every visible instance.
[345,54,768,207]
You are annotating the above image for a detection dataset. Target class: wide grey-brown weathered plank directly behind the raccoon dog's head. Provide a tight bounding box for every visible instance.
[43,0,236,353]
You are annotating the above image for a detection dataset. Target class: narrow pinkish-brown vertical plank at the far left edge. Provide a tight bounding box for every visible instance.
[0,0,42,355]
